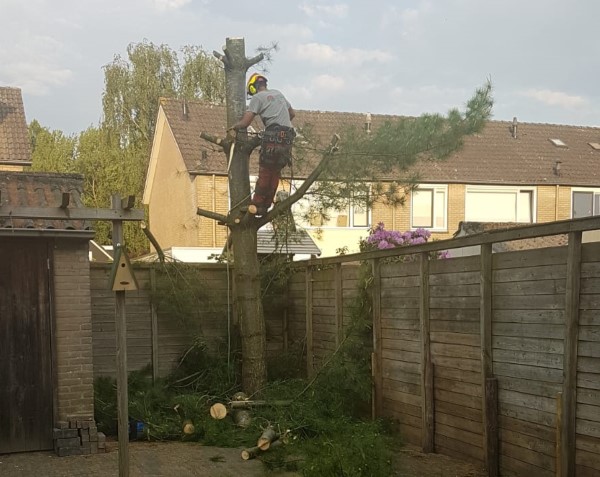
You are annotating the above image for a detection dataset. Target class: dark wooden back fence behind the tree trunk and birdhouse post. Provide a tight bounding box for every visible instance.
[91,263,292,377]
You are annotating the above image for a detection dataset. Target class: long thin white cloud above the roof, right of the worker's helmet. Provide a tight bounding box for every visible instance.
[293,43,393,67]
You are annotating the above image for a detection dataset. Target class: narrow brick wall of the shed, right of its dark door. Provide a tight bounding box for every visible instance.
[52,240,94,421]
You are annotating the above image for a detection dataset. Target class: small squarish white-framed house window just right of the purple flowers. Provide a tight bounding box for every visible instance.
[410,184,448,230]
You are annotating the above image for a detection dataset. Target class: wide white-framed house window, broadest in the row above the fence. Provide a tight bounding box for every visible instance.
[465,186,535,223]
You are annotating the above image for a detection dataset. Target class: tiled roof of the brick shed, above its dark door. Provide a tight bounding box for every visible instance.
[0,172,91,230]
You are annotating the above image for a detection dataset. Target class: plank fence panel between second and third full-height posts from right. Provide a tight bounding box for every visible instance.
[429,256,483,462]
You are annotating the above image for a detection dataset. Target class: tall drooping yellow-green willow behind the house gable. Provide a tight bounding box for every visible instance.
[102,41,225,253]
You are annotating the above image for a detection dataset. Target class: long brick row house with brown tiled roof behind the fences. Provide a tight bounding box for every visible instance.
[143,99,600,256]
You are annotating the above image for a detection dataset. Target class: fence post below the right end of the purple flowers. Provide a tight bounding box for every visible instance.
[419,252,435,452]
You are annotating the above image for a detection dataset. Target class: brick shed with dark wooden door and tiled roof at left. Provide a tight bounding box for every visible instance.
[0,171,97,455]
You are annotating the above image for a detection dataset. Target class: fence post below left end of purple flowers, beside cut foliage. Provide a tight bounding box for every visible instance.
[371,259,383,418]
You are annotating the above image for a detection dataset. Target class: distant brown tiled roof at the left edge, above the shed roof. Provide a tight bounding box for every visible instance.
[0,87,31,165]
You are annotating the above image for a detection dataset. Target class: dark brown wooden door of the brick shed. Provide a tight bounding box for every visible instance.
[0,238,53,453]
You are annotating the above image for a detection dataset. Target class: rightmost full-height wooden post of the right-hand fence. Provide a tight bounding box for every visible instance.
[560,232,581,476]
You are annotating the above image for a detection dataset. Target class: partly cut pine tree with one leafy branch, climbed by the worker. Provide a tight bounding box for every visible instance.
[198,38,492,393]
